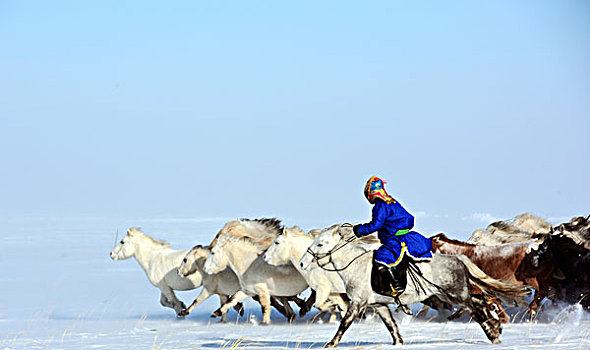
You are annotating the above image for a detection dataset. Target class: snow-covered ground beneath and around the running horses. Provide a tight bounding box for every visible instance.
[0,218,590,349]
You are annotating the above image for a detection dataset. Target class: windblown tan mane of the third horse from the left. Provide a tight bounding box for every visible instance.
[209,218,283,249]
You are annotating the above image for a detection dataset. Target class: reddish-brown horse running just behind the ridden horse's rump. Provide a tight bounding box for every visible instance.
[430,233,545,323]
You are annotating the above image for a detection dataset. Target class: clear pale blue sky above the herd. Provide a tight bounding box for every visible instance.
[0,1,590,237]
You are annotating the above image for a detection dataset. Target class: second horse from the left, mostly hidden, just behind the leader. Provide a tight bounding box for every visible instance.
[178,245,291,322]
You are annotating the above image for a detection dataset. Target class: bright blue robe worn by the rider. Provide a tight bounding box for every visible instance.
[358,199,432,266]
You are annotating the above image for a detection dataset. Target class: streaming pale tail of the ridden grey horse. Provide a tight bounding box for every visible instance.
[457,255,531,300]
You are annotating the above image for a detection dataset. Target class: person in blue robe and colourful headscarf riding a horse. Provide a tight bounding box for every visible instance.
[353,176,432,297]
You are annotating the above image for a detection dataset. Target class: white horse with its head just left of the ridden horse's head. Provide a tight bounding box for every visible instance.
[264,226,348,321]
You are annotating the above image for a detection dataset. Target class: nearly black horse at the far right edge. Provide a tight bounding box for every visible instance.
[515,234,590,310]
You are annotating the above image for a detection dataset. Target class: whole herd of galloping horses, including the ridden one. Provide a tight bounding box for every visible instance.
[110,213,590,347]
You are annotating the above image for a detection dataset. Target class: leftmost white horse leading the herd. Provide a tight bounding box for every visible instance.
[110,227,202,317]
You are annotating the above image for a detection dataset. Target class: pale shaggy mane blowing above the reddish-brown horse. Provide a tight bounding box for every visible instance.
[467,213,551,245]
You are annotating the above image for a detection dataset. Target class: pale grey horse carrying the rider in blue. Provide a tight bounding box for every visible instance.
[300,225,527,347]
